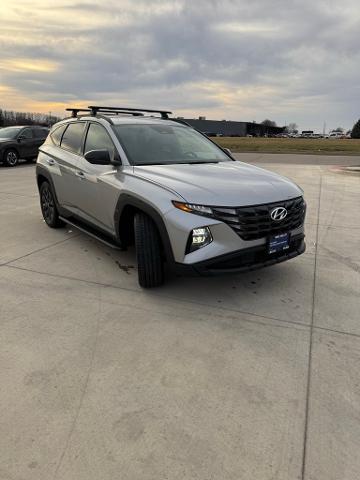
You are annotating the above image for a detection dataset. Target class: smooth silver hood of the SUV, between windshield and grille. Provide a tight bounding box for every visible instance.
[134,161,302,207]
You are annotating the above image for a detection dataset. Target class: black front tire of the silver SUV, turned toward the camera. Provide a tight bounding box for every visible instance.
[134,213,164,288]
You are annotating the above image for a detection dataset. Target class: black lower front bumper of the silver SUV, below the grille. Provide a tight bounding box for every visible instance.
[175,234,306,275]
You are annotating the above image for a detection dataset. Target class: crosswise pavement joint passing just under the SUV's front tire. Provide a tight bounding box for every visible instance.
[3,265,310,328]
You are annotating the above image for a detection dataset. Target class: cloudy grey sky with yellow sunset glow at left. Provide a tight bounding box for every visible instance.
[0,0,360,131]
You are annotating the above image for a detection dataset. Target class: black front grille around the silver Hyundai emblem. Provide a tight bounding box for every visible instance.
[211,197,306,240]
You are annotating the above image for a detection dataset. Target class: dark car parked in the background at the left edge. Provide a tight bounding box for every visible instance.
[0,125,49,167]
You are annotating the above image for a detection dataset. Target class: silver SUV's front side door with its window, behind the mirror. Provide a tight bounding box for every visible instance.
[76,122,119,233]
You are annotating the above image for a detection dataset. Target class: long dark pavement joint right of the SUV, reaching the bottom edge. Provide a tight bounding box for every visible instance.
[301,172,322,480]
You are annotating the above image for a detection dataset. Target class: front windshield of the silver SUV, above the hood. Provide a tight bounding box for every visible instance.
[113,124,230,165]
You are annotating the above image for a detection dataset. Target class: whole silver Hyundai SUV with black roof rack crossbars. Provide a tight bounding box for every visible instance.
[36,106,306,287]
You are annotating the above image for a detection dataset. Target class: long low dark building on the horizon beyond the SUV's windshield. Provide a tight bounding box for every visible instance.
[179,117,285,137]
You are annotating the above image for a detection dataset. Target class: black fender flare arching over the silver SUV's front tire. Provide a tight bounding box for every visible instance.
[114,193,175,264]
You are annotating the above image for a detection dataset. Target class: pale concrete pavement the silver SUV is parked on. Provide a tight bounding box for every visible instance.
[0,154,360,480]
